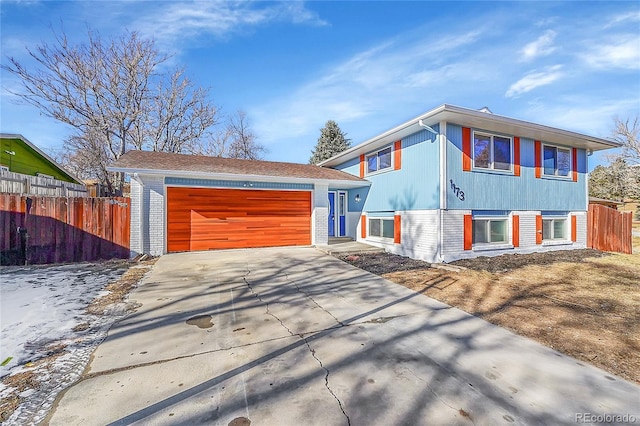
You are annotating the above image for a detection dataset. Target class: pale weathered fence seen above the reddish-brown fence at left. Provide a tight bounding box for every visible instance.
[0,170,88,197]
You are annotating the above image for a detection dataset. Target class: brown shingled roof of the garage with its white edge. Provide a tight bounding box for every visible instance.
[109,150,370,187]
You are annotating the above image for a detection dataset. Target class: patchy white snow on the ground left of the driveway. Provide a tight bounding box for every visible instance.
[0,262,131,425]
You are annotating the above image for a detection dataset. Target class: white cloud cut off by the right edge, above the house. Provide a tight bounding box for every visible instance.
[582,34,640,70]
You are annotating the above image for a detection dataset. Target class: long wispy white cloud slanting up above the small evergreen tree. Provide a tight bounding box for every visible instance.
[250,31,480,143]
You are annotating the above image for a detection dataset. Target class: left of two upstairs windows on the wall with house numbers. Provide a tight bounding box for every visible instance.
[473,132,513,171]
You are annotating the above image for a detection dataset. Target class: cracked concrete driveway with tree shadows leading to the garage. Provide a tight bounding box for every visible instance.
[48,248,640,426]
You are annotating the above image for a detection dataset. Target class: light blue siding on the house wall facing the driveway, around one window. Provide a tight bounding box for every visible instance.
[336,130,440,212]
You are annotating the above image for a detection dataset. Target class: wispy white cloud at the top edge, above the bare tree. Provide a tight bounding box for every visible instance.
[134,1,327,43]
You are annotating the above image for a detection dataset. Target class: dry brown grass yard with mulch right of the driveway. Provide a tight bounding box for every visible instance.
[340,250,640,383]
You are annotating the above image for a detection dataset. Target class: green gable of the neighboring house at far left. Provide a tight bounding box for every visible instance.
[0,133,83,185]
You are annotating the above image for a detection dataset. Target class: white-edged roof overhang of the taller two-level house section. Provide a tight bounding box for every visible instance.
[320,104,620,167]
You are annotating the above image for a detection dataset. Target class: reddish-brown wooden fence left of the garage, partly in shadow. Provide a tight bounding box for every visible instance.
[0,194,131,265]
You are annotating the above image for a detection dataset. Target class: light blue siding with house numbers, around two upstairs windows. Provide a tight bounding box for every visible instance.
[445,123,587,211]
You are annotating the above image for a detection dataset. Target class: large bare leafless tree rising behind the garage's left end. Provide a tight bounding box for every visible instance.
[2,26,217,193]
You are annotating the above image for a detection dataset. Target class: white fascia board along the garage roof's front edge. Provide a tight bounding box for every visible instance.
[107,167,371,189]
